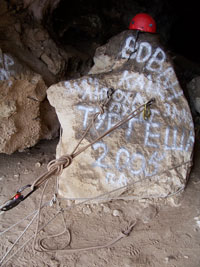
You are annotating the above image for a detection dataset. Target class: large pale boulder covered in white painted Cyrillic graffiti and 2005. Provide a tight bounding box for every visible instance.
[47,31,194,199]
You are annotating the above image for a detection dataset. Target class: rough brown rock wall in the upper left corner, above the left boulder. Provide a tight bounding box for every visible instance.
[0,0,93,86]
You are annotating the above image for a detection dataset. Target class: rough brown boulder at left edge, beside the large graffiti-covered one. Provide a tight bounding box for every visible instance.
[0,52,59,154]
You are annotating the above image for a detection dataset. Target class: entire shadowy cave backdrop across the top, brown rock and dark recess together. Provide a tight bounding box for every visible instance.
[0,0,200,85]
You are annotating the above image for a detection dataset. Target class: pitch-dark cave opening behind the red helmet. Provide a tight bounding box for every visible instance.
[43,0,200,63]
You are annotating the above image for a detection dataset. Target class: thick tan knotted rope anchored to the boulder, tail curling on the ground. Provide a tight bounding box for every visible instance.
[28,95,155,253]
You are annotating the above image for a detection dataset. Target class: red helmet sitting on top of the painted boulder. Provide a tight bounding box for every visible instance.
[129,13,156,33]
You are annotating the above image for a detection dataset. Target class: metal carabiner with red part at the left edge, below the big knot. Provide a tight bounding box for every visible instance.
[0,184,36,211]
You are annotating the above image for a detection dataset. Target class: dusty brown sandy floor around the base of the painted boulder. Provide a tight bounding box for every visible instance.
[0,139,200,267]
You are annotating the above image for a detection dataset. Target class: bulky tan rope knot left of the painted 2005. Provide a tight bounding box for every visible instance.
[47,155,73,175]
